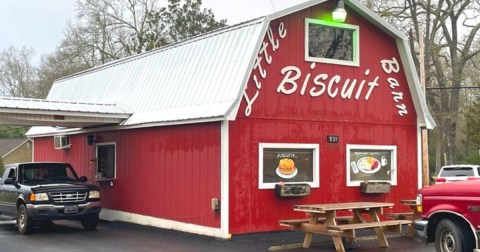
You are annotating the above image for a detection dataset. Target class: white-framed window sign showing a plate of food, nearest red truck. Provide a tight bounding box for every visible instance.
[347,144,397,186]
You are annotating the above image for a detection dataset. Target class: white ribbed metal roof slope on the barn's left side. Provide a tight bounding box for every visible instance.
[47,18,266,125]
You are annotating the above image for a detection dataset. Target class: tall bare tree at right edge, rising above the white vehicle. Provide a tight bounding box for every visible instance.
[432,0,480,163]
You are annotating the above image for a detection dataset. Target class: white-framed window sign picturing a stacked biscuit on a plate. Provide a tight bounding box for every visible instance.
[258,143,319,189]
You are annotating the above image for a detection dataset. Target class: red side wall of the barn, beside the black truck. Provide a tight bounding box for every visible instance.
[35,123,220,228]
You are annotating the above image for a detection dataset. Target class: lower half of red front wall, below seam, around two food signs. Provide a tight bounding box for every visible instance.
[230,119,417,233]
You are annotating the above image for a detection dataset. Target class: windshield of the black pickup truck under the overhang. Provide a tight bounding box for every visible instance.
[18,163,78,183]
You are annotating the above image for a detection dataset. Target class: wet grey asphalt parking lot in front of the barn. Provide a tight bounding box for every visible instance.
[0,221,435,252]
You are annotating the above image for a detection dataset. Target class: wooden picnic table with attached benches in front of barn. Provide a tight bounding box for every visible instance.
[280,202,411,252]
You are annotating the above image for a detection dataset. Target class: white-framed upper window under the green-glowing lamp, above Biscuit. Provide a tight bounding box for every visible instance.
[305,18,360,66]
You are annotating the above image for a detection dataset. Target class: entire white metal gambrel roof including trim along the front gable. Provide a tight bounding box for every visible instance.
[0,0,435,135]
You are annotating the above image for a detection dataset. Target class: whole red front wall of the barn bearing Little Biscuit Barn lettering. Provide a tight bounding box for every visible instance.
[229,3,418,233]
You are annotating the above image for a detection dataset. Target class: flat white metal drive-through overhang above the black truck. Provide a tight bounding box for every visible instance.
[0,97,132,128]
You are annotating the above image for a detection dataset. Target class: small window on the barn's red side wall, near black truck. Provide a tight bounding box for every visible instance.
[96,143,116,179]
